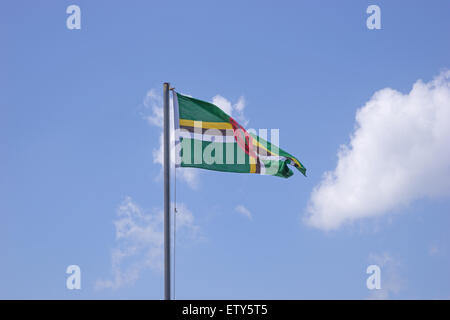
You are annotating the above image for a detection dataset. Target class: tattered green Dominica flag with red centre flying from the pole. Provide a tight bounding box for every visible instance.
[173,91,306,178]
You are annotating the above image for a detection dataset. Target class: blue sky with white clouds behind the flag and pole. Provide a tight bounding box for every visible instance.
[0,1,450,299]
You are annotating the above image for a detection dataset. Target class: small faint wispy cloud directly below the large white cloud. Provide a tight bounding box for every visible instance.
[368,253,405,300]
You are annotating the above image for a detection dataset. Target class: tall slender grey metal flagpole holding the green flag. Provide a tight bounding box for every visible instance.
[163,82,170,300]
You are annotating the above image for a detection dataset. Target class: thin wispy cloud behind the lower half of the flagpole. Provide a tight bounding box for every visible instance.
[95,197,199,289]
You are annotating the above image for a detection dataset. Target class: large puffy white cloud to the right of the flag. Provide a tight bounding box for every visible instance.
[305,71,450,230]
